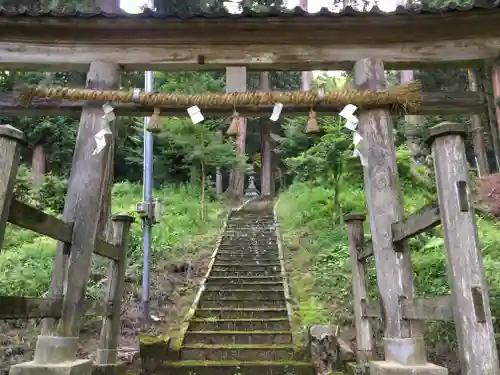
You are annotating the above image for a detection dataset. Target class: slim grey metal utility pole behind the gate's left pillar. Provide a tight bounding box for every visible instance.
[142,0,154,327]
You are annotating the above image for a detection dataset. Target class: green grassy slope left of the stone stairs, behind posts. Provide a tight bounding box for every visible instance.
[0,182,224,297]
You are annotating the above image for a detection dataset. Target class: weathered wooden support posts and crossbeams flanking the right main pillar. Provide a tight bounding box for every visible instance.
[344,123,496,375]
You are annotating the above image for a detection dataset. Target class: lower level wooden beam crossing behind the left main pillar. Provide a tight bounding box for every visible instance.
[0,296,113,320]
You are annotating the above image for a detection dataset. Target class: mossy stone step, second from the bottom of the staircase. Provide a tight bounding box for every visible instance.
[180,344,296,361]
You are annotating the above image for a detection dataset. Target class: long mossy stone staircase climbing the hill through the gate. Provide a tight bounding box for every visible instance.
[154,201,313,375]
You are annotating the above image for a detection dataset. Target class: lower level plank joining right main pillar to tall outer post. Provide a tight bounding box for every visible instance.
[401,296,454,321]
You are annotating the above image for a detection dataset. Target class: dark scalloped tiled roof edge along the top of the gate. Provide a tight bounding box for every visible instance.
[0,0,500,19]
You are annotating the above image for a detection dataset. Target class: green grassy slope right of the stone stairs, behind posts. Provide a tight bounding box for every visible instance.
[278,154,500,350]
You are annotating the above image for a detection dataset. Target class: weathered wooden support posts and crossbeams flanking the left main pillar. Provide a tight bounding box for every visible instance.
[0,125,133,369]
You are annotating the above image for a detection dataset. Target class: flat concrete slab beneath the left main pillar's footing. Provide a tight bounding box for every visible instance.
[9,359,92,375]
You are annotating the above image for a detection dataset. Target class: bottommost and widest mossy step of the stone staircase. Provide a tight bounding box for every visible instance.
[155,361,314,375]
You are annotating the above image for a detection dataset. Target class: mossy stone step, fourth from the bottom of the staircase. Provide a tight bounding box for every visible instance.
[188,318,290,331]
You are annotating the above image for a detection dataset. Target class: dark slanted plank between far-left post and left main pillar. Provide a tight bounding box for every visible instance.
[9,199,73,243]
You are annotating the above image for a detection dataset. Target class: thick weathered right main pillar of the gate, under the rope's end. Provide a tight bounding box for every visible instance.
[354,59,425,364]
